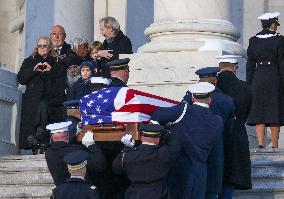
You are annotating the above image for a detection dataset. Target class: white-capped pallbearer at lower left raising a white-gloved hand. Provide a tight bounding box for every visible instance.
[45,122,106,186]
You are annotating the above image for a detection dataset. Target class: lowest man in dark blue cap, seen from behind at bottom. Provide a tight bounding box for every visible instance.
[50,150,100,199]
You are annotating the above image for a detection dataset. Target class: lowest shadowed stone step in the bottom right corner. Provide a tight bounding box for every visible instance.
[233,188,284,199]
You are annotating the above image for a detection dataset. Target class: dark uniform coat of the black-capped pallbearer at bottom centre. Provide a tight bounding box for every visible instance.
[113,136,179,199]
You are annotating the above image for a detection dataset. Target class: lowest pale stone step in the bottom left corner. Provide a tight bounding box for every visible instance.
[0,184,54,198]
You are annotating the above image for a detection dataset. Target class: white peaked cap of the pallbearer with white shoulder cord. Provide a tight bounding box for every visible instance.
[188,82,215,99]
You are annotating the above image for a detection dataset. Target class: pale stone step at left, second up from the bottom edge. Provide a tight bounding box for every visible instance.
[0,171,53,185]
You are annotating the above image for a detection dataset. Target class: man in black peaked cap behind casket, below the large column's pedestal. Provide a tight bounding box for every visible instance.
[106,58,130,87]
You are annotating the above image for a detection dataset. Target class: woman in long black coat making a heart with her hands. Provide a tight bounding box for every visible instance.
[17,37,66,153]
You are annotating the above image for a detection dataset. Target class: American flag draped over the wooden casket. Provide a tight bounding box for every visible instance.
[79,87,178,125]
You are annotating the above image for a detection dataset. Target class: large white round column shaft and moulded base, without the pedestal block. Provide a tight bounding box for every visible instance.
[139,0,244,55]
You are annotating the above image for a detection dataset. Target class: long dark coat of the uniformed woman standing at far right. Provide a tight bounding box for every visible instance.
[246,29,284,126]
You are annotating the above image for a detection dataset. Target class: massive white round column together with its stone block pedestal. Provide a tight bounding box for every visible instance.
[120,0,245,100]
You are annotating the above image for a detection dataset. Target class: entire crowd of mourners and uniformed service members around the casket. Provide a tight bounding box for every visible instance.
[17,12,284,199]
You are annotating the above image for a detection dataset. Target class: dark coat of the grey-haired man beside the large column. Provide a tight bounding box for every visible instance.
[103,31,133,62]
